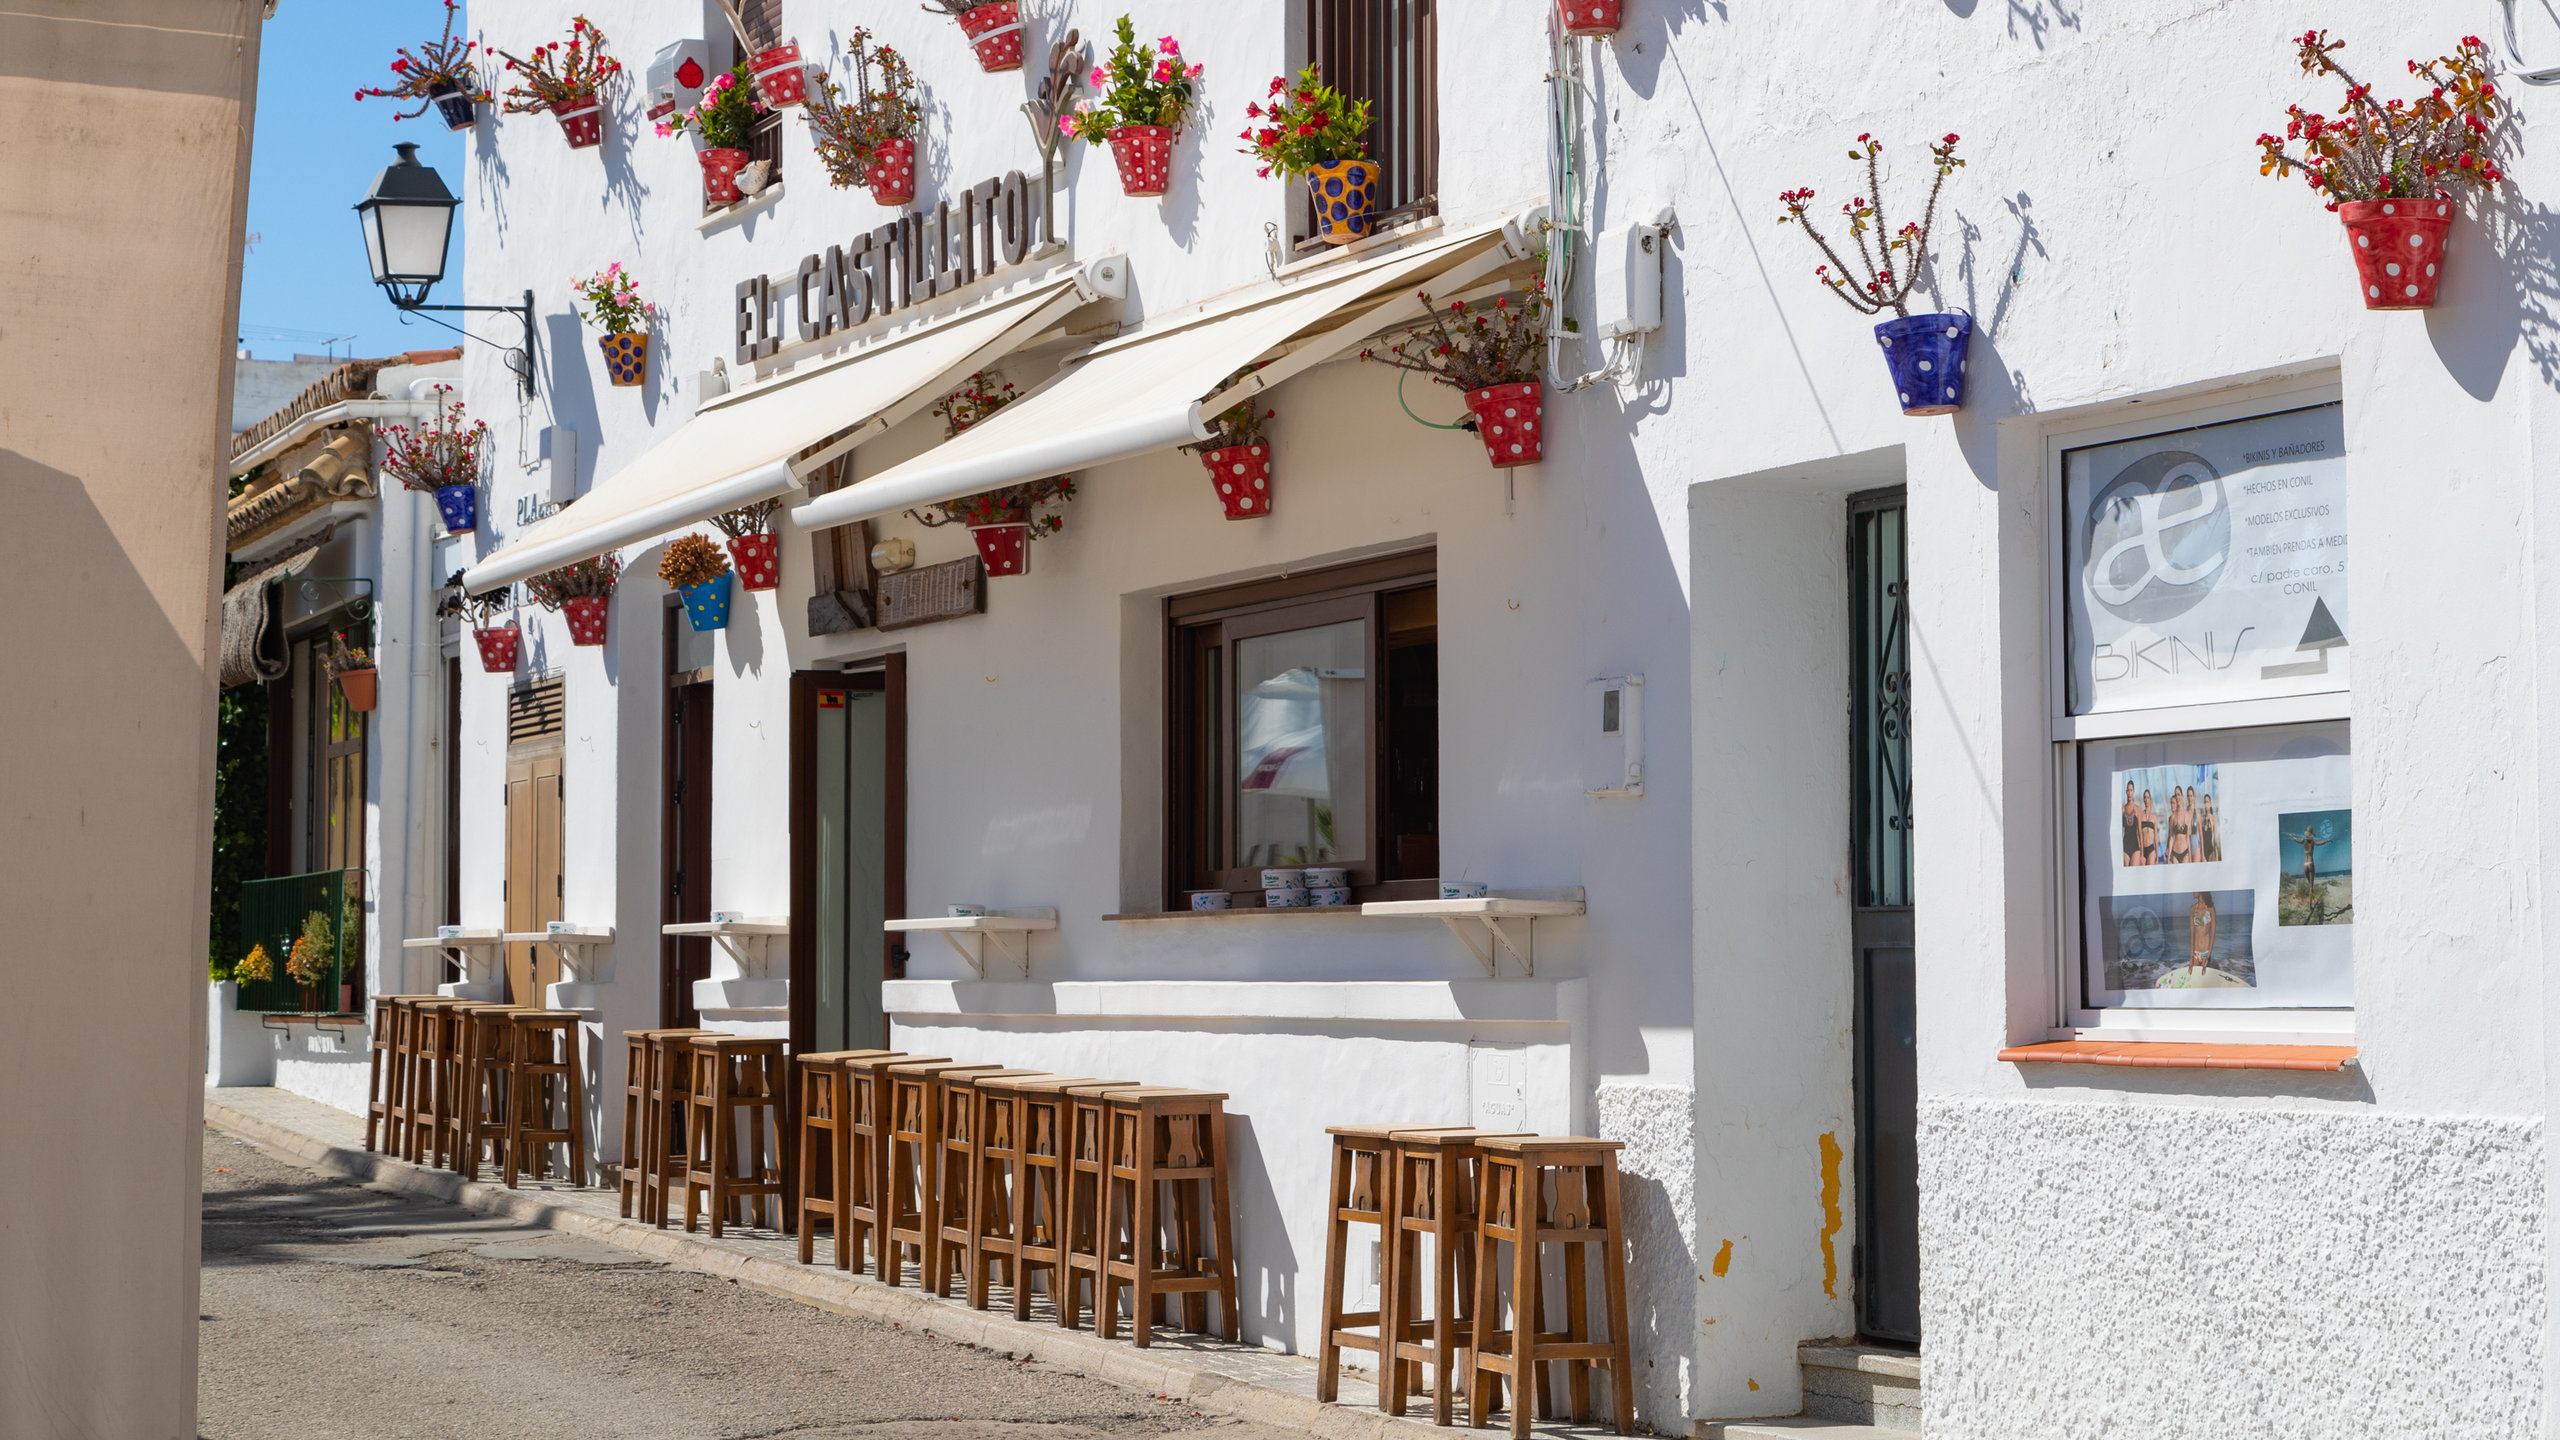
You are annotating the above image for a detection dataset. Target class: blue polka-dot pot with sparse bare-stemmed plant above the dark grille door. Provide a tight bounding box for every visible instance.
[1777,136,1974,415]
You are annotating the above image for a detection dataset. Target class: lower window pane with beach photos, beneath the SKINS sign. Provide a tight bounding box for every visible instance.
[2081,720,2355,1010]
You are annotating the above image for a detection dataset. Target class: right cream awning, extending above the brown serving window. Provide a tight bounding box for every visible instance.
[791,210,1528,528]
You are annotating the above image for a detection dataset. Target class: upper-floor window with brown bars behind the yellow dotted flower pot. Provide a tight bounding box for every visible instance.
[1298,0,1439,236]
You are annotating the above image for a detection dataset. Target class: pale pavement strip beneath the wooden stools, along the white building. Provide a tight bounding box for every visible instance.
[205,1086,1608,1440]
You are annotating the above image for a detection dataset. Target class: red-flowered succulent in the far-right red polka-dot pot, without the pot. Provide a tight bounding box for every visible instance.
[2258,31,2506,210]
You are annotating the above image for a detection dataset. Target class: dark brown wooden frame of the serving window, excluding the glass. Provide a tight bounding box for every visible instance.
[1165,551,1439,910]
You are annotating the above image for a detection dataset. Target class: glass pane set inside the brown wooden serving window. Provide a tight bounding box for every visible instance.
[1234,620,1370,866]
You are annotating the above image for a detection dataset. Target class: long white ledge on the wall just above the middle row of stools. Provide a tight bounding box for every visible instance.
[881,979,1585,1025]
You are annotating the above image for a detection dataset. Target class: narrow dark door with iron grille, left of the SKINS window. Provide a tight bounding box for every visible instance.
[1848,487,1920,1345]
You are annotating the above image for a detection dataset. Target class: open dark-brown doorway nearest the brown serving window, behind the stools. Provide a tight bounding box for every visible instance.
[791,656,906,1053]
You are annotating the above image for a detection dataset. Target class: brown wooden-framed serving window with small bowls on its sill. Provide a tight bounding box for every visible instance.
[1165,551,1439,907]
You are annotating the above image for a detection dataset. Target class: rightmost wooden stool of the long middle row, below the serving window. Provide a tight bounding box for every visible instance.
[1093,1086,1236,1350]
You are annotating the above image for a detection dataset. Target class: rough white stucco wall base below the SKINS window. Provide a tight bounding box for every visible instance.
[1920,1099,2545,1440]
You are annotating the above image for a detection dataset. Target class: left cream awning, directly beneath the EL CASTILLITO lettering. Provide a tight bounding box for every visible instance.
[463,274,1088,594]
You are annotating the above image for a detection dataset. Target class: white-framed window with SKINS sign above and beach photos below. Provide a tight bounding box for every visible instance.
[2056,402,2355,1022]
